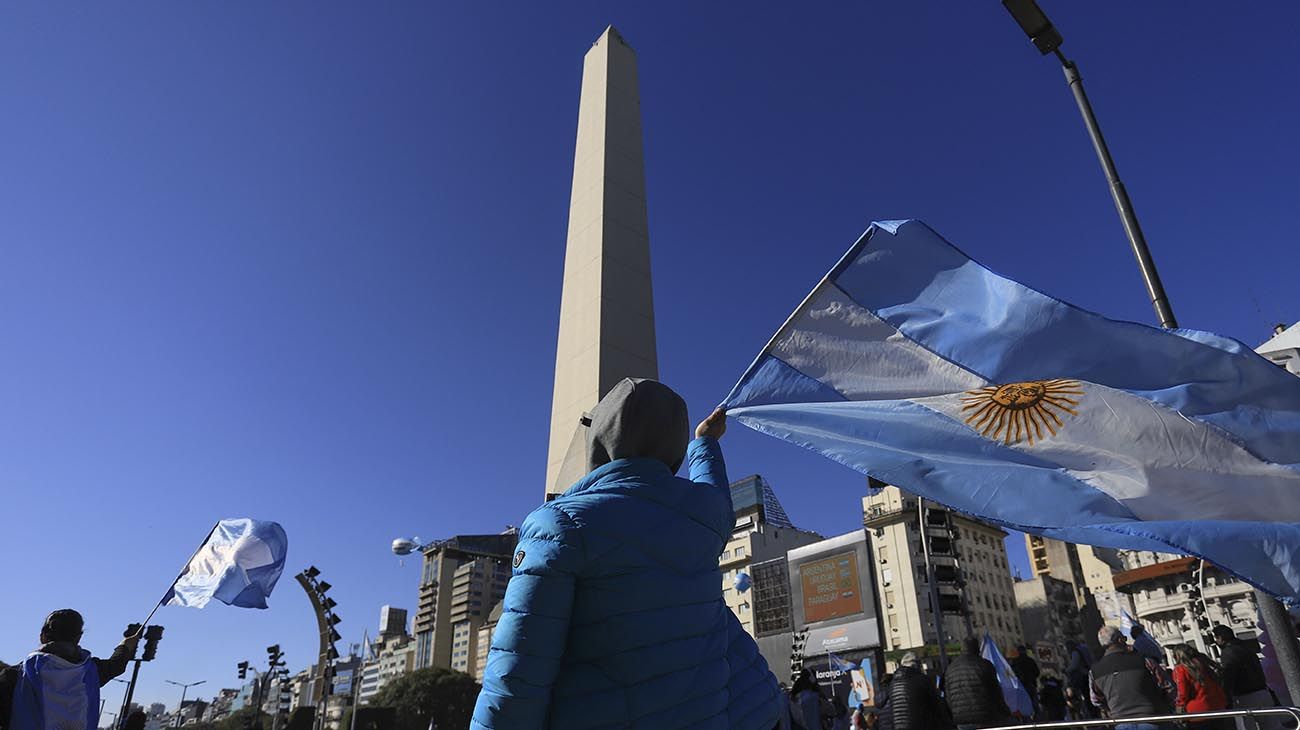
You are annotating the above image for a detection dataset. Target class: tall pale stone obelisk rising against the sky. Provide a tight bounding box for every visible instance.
[546,26,659,499]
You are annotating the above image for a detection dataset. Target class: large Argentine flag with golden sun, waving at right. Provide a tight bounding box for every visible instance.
[723,221,1300,601]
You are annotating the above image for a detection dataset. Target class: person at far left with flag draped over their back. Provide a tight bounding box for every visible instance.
[0,608,139,730]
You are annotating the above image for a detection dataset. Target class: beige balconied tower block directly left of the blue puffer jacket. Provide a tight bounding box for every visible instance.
[415,527,519,674]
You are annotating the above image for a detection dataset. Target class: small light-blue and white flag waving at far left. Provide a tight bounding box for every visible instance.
[163,517,289,608]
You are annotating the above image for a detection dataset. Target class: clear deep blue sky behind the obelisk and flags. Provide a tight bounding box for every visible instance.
[0,0,1300,705]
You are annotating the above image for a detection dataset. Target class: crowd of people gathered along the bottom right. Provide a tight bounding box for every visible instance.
[780,623,1283,730]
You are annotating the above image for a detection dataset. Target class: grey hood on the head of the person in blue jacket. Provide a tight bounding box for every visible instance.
[586,378,690,473]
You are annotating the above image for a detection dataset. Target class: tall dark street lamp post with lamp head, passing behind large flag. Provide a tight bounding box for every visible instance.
[1002,0,1300,701]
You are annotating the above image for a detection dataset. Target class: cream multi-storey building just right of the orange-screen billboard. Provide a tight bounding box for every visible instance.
[862,485,1024,659]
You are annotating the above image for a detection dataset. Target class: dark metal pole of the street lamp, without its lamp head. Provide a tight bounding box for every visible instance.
[1044,37,1300,701]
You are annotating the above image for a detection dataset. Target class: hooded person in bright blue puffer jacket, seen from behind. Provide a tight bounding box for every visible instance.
[472,378,781,730]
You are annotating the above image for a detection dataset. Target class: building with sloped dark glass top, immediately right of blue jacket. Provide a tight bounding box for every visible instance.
[718,474,822,636]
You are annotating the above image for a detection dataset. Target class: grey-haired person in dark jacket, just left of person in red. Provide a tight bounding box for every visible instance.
[1089,618,1170,730]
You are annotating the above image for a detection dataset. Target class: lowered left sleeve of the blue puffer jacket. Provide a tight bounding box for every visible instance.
[471,505,582,730]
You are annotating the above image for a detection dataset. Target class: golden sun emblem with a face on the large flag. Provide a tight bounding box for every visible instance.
[962,379,1083,446]
